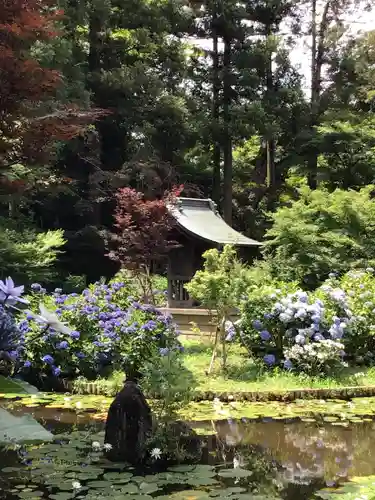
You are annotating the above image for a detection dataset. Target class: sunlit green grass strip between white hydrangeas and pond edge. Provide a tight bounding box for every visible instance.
[179,340,375,392]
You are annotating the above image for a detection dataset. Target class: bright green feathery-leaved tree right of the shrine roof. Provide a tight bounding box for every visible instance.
[264,186,375,289]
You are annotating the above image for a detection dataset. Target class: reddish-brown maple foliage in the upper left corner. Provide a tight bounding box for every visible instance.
[0,0,101,176]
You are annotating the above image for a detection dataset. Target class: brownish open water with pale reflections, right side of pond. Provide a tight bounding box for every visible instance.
[209,421,375,483]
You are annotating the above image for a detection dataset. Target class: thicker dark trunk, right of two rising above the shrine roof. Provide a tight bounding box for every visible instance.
[223,39,233,226]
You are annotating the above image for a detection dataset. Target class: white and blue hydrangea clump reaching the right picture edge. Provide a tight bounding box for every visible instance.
[242,268,375,373]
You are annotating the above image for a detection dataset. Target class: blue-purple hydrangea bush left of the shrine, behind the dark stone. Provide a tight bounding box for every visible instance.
[19,282,180,379]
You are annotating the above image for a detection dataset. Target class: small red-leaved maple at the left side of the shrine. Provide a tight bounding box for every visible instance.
[108,186,183,299]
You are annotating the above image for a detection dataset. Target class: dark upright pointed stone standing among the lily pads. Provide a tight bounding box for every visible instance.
[104,373,152,465]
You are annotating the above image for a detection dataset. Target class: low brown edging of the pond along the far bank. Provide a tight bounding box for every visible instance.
[65,381,375,402]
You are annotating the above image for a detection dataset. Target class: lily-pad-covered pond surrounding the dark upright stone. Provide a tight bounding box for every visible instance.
[0,400,375,500]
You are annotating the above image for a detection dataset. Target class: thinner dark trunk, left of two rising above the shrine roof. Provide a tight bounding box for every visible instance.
[212,12,221,207]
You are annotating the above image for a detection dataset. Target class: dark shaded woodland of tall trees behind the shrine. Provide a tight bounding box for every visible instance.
[0,0,375,287]
